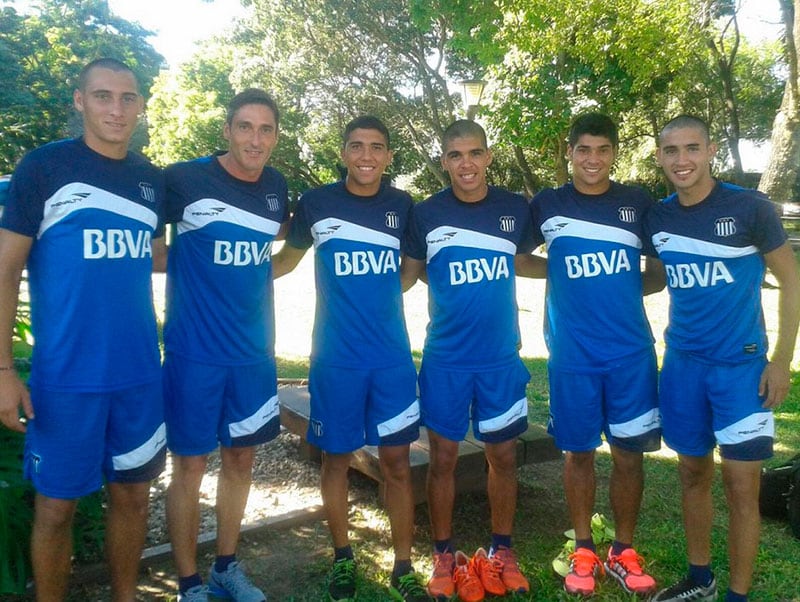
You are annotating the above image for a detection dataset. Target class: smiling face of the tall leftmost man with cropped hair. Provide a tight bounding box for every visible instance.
[72,67,144,159]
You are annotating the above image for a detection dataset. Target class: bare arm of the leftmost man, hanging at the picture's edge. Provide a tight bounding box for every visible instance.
[0,228,33,432]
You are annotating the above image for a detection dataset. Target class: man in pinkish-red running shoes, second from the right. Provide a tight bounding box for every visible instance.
[517,113,664,596]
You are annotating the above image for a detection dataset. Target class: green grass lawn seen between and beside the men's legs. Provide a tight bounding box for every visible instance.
[279,358,800,602]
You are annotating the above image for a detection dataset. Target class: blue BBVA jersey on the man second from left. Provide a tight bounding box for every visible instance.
[164,157,288,365]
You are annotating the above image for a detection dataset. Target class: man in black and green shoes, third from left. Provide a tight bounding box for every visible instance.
[273,116,429,602]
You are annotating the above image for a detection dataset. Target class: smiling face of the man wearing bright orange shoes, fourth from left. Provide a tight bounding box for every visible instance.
[442,136,492,203]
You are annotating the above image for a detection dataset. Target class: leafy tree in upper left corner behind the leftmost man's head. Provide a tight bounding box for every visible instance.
[0,0,163,172]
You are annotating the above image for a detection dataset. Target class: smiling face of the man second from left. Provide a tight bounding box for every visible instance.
[219,103,278,182]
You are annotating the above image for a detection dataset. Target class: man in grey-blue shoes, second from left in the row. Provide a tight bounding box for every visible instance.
[164,89,288,602]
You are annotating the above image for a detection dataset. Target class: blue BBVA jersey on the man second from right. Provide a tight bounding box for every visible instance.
[531,182,653,372]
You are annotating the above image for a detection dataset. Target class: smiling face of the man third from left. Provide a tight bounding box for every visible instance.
[342,128,393,196]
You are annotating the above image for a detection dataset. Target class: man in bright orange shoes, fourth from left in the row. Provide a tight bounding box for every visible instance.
[403,120,531,600]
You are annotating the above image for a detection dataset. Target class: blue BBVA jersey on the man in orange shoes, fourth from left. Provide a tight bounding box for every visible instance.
[407,186,532,371]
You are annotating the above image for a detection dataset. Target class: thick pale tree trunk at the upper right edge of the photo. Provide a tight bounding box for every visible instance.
[758,0,800,203]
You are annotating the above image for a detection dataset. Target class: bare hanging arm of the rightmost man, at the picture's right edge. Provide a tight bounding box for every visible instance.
[758,242,800,408]
